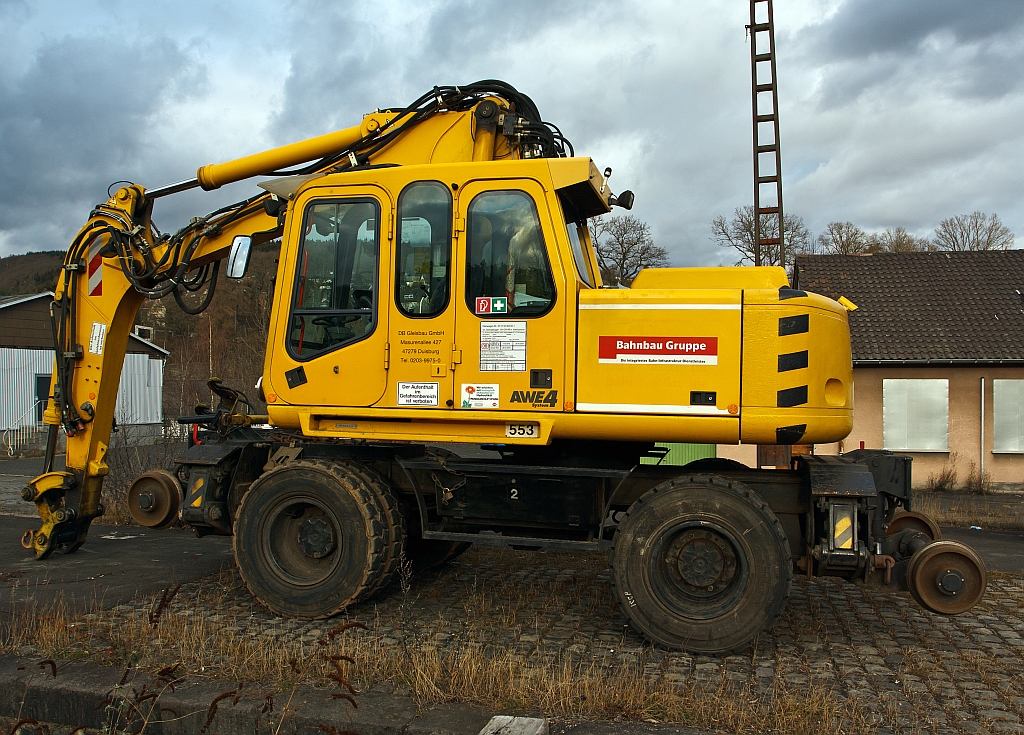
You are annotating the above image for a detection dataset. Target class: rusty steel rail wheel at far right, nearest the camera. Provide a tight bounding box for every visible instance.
[906,541,988,615]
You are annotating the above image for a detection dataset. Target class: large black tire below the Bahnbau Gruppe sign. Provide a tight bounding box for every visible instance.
[611,475,793,654]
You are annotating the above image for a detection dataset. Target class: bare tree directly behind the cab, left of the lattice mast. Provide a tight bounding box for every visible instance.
[590,214,669,286]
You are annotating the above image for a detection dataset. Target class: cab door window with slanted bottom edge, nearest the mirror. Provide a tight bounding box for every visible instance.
[288,200,380,359]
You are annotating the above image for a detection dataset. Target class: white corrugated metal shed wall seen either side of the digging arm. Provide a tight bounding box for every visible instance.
[0,347,164,429]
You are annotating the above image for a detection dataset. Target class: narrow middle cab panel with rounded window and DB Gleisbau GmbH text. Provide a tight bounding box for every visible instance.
[378,180,455,408]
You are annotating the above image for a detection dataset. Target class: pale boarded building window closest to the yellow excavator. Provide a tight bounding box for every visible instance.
[882,380,949,451]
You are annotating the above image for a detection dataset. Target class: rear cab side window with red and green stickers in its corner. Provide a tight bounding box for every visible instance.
[466,191,555,316]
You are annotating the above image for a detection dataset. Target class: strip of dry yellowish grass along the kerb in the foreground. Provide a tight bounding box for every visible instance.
[0,574,870,734]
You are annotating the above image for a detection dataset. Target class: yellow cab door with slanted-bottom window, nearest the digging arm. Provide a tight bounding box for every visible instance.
[270,186,392,406]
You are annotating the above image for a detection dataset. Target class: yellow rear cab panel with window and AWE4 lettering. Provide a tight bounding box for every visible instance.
[454,179,567,412]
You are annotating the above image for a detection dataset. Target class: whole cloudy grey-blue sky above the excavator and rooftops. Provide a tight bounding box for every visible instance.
[0,0,1024,265]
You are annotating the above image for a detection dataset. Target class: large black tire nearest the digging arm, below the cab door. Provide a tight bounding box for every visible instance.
[233,460,387,619]
